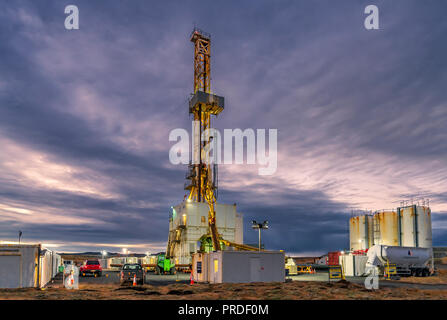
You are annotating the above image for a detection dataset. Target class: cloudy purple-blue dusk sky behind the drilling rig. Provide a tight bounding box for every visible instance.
[0,0,447,254]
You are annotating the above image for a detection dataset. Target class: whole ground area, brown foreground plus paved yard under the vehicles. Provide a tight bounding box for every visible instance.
[0,270,447,300]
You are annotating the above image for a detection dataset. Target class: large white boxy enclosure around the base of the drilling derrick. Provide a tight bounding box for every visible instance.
[169,201,243,265]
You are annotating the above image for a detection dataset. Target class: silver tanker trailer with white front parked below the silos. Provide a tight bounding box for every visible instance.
[366,245,432,277]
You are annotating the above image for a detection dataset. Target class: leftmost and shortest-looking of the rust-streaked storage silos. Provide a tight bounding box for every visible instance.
[349,215,373,250]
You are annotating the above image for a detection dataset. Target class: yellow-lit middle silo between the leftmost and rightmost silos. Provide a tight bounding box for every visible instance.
[374,210,400,246]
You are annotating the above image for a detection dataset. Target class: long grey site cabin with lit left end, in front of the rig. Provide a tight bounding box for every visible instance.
[192,251,285,283]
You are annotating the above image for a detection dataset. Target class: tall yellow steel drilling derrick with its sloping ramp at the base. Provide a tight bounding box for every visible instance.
[166,28,258,258]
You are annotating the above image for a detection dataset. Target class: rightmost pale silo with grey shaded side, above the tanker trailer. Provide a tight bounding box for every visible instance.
[397,205,433,248]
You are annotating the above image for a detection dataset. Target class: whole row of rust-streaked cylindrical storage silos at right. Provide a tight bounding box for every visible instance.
[349,205,432,251]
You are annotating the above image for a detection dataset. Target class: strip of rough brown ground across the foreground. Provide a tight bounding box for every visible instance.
[0,281,447,300]
